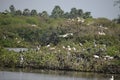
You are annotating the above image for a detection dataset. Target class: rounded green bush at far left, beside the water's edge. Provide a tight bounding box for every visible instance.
[0,48,19,67]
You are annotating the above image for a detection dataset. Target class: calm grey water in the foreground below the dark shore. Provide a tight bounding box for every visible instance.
[0,71,120,80]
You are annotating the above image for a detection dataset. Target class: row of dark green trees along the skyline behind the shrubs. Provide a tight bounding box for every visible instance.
[5,5,92,19]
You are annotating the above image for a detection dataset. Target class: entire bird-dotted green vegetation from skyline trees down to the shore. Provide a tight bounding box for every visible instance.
[0,5,120,73]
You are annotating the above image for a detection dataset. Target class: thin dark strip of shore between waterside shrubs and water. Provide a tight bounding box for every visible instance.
[0,64,120,74]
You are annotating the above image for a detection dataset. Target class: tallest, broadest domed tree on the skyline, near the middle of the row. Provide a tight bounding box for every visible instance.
[51,6,64,18]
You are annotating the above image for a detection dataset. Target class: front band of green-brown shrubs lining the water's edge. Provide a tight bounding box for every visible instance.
[0,48,120,74]
